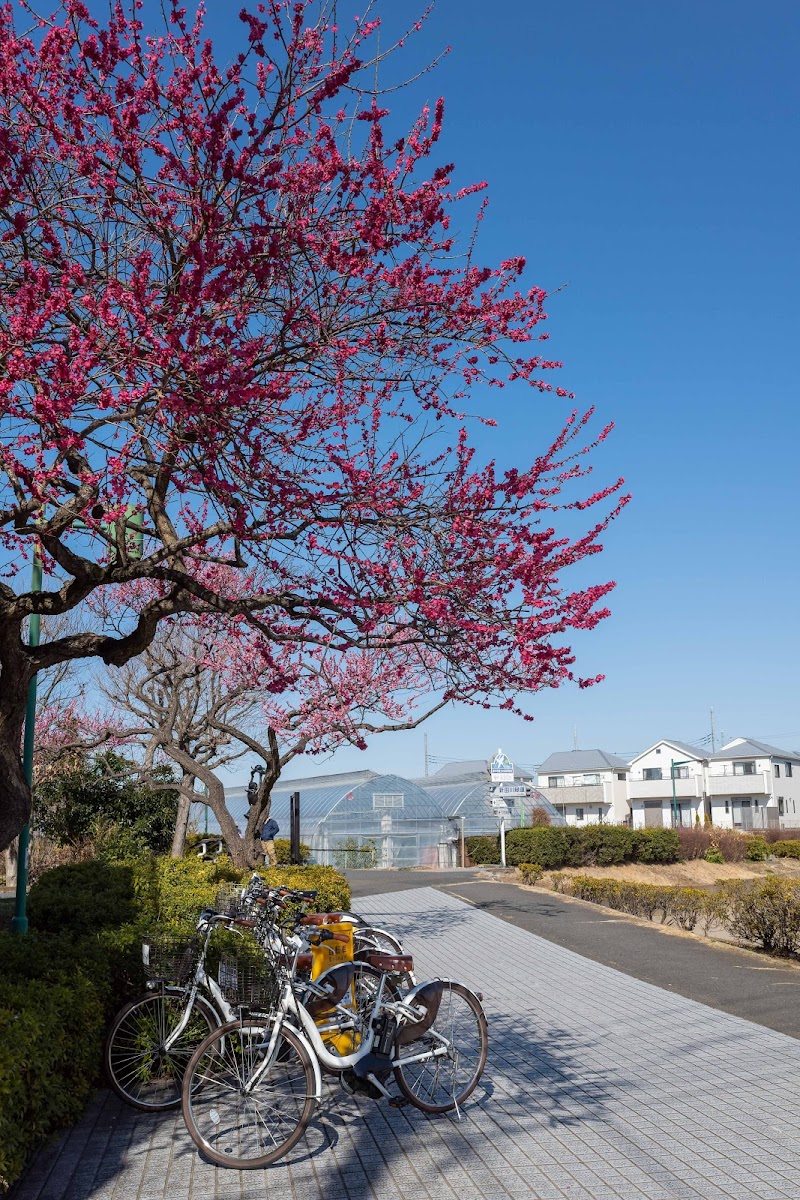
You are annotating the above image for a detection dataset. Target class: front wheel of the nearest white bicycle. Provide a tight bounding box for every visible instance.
[182,1019,315,1171]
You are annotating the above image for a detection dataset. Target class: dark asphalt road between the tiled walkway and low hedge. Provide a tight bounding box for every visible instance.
[347,870,800,1038]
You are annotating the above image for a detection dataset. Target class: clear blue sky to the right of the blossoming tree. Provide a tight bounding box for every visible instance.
[272,0,800,774]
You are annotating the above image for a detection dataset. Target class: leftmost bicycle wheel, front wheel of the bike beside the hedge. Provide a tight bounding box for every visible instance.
[103,991,219,1112]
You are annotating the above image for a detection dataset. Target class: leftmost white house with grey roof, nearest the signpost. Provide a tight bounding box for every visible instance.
[537,750,630,826]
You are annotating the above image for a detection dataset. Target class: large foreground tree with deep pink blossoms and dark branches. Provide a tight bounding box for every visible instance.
[0,0,622,846]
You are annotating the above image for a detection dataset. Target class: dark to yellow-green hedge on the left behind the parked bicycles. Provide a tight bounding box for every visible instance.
[0,857,350,1193]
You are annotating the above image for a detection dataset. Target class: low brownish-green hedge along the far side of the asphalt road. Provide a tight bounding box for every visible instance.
[551,874,800,956]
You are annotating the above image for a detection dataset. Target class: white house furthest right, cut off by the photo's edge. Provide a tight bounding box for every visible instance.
[706,738,800,829]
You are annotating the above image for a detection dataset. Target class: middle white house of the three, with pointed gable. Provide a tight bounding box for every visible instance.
[627,738,710,829]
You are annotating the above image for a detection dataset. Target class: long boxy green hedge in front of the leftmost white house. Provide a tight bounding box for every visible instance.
[506,824,680,871]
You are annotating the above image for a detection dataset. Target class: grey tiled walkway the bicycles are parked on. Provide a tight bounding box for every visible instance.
[14,888,800,1200]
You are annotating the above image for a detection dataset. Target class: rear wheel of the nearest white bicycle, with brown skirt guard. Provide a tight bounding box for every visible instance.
[395,980,488,1112]
